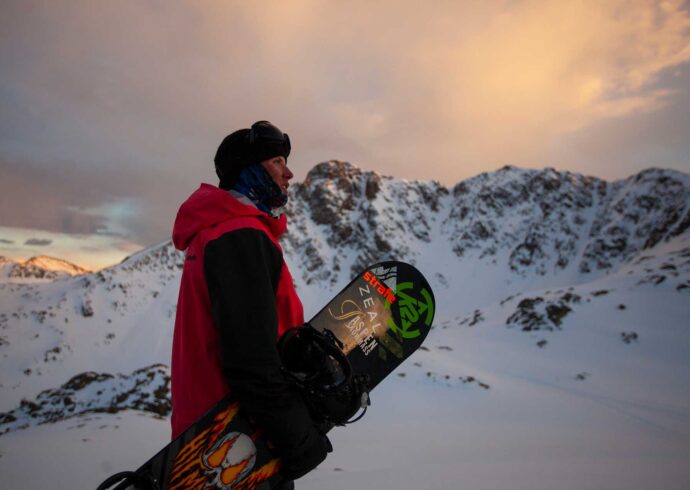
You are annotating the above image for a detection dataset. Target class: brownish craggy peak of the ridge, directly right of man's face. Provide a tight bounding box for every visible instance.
[286,161,448,284]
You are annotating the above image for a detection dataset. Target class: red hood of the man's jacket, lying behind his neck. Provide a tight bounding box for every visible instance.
[172,184,287,250]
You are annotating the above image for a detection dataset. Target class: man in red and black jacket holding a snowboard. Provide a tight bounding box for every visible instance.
[167,121,330,488]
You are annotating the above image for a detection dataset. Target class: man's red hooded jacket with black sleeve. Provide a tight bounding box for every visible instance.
[171,184,316,451]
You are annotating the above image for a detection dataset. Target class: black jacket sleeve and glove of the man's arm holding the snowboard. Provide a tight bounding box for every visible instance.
[204,228,325,466]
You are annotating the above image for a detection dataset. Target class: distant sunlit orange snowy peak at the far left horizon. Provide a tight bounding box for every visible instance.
[0,255,90,282]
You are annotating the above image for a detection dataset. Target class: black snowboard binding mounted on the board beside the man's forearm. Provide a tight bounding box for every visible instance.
[278,323,371,427]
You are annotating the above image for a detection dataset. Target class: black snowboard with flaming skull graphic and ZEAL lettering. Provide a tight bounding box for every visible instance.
[99,261,435,490]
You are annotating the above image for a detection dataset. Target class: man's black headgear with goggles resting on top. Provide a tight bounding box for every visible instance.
[214,121,291,190]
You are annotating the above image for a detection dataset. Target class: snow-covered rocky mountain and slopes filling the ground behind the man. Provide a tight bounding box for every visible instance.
[0,165,690,490]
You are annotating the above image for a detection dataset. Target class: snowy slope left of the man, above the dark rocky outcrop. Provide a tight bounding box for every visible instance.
[0,242,182,411]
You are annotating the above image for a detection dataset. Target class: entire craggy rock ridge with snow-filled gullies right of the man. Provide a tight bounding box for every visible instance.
[285,161,690,284]
